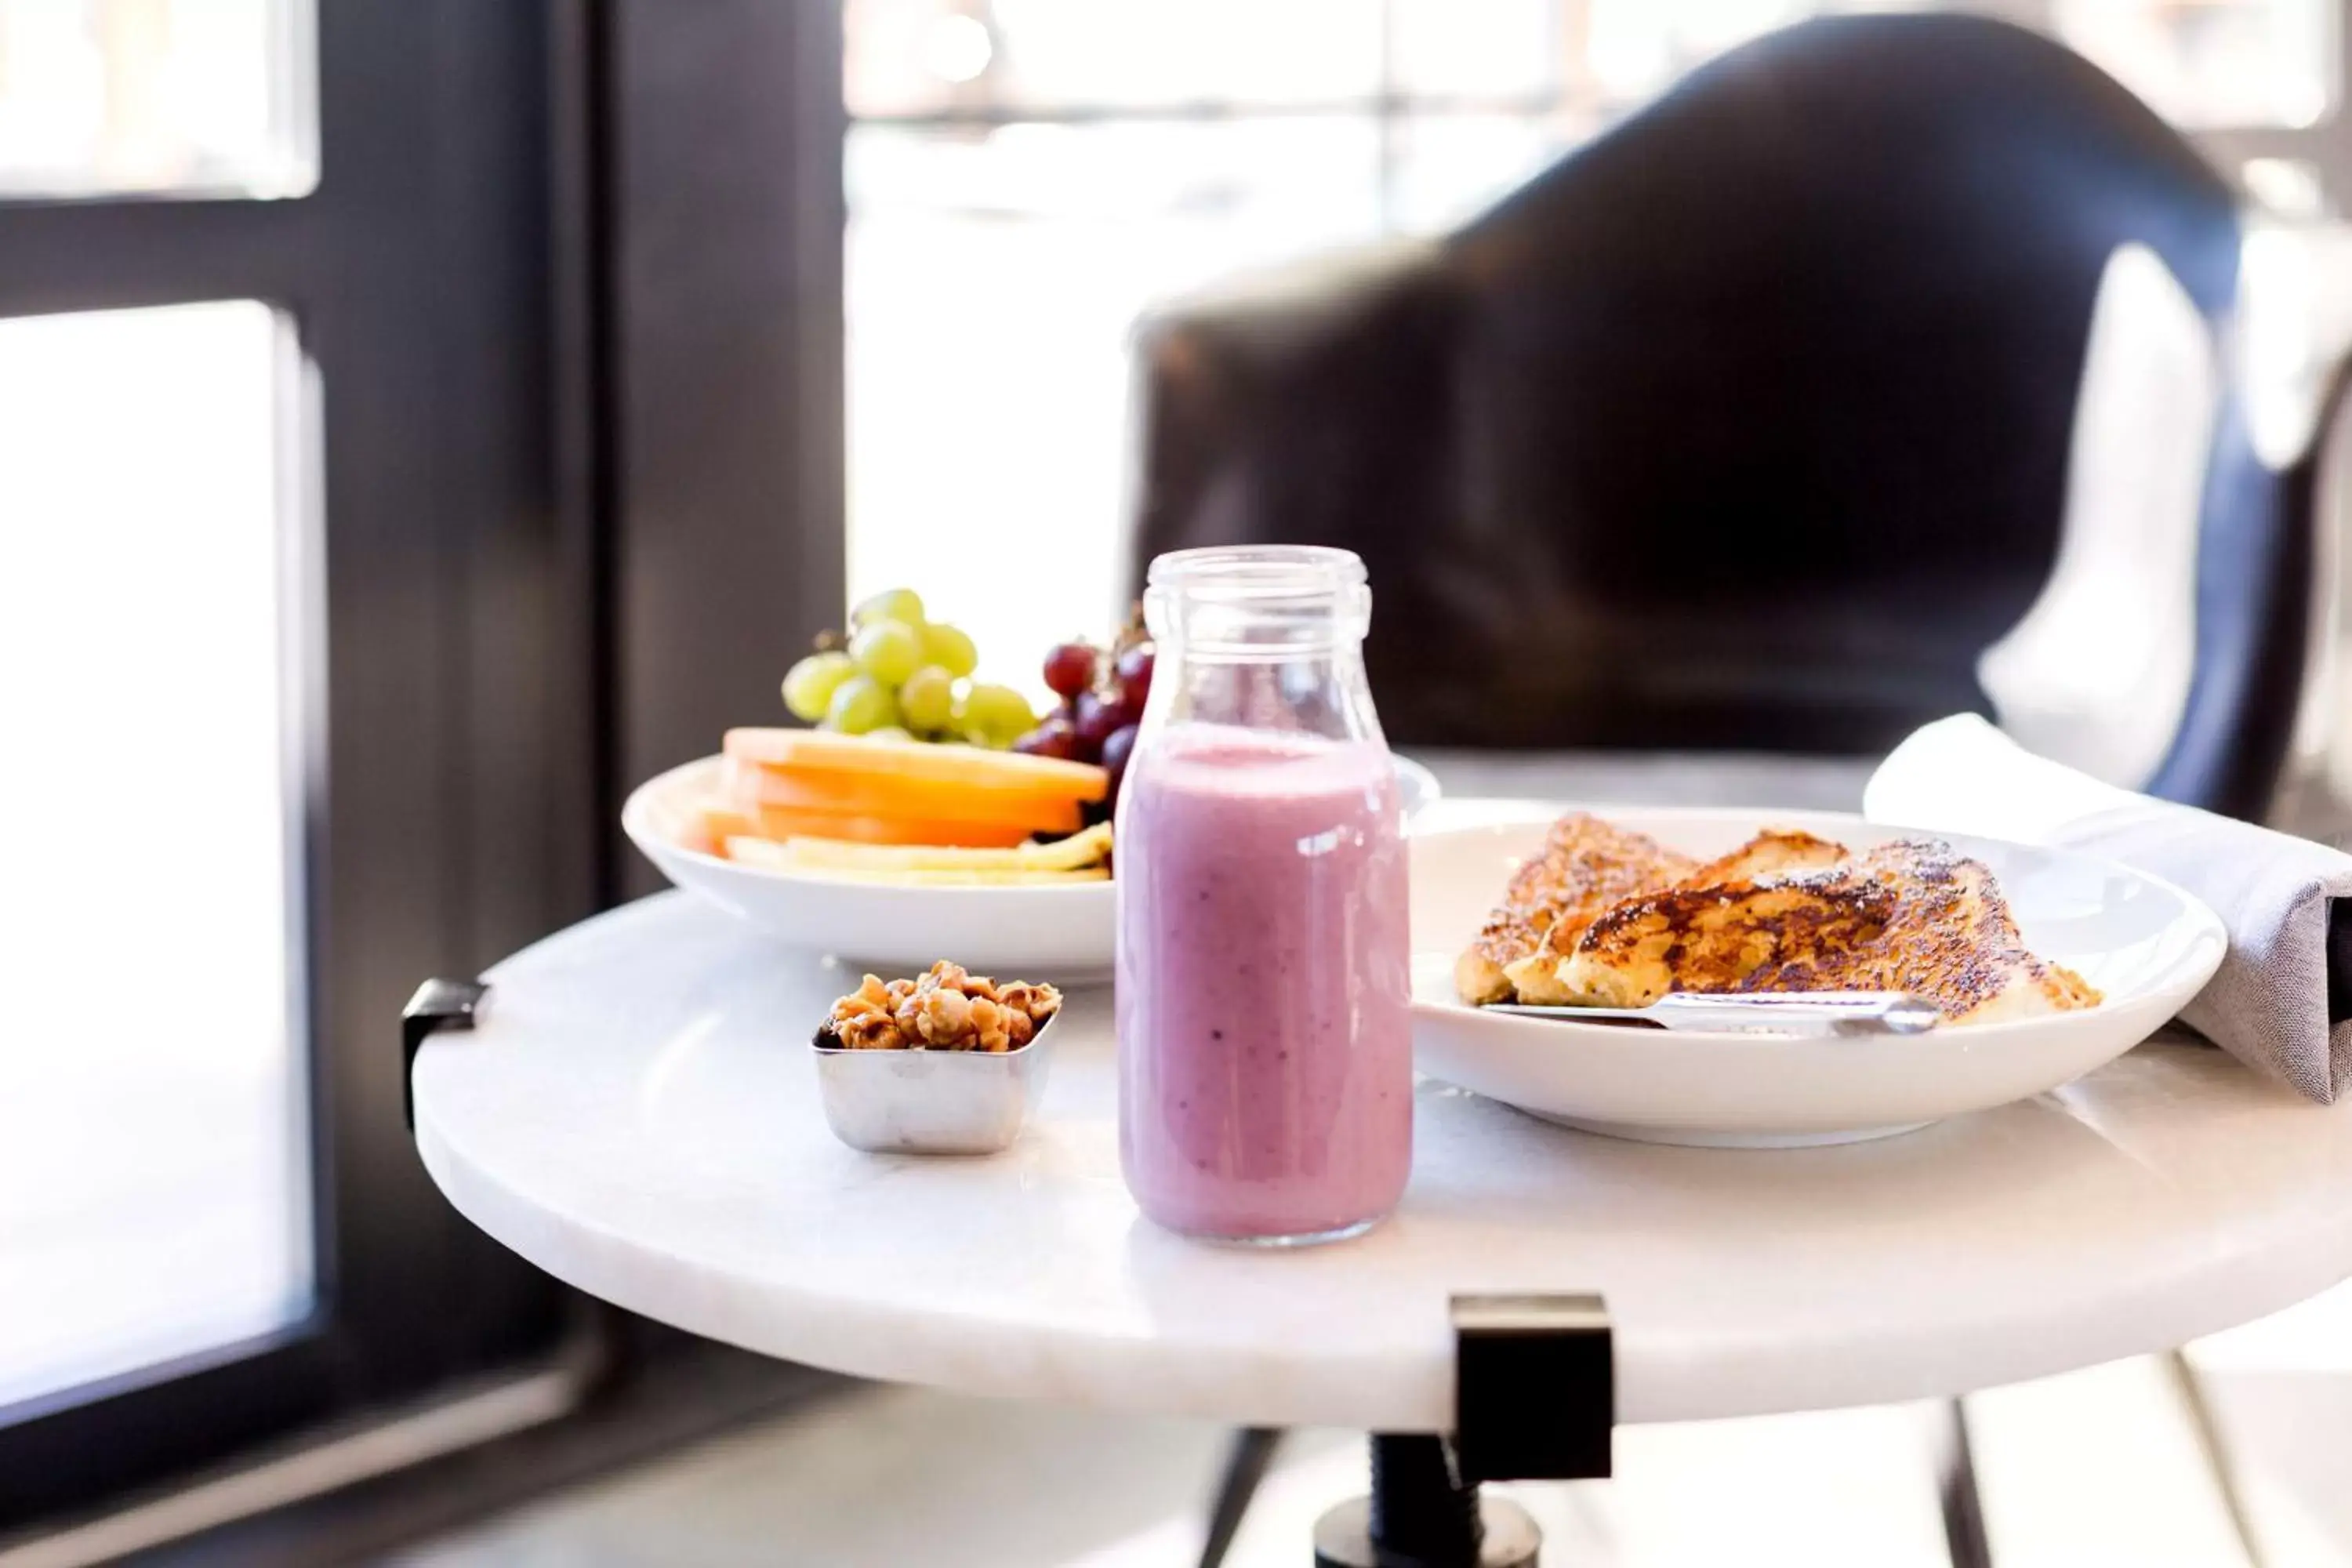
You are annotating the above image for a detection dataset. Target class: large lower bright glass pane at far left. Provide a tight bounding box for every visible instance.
[0,301,313,1406]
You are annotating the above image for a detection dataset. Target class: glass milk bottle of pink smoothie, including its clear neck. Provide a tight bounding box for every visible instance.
[1117,546,1414,1246]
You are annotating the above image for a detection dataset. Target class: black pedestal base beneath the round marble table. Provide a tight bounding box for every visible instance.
[1315,1434,1543,1568]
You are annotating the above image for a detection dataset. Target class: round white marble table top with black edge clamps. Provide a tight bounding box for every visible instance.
[416,893,2352,1432]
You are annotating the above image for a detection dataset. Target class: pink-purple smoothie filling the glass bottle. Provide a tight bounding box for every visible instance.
[1117,724,1414,1239]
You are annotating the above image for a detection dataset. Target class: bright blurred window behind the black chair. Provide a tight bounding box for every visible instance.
[844,0,2338,694]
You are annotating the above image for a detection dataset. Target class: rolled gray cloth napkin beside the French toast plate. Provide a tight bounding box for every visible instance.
[1863,715,2352,1105]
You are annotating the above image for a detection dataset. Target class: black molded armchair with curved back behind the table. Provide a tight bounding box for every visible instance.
[1131,16,2324,815]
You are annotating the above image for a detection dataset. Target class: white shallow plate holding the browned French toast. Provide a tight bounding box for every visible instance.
[1414,806,2227,1147]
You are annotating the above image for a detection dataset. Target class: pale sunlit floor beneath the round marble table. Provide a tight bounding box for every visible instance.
[397,1298,2352,1568]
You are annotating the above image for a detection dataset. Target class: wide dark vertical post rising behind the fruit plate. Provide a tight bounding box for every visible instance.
[609,0,847,891]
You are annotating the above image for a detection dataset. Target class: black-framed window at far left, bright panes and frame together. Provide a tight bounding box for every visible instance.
[0,0,583,1554]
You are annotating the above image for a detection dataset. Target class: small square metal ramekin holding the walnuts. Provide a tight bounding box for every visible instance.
[811,1013,1061,1154]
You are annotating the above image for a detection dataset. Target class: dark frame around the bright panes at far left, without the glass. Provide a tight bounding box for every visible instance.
[0,0,609,1530]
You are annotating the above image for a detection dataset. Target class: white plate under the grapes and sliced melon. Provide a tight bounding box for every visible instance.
[621,757,1437,982]
